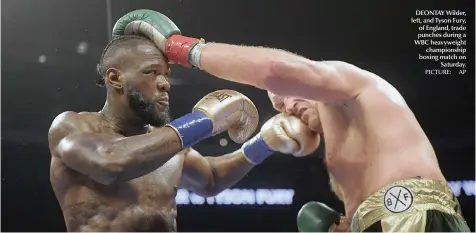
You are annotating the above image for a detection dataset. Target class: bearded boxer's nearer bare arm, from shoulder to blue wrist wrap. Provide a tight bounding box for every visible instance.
[49,112,182,185]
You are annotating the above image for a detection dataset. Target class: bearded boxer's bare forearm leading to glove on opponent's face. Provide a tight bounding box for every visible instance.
[205,150,254,196]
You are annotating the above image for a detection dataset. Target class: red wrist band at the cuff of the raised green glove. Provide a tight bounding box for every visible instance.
[165,35,204,67]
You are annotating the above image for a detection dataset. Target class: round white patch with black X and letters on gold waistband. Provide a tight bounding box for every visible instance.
[383,185,413,213]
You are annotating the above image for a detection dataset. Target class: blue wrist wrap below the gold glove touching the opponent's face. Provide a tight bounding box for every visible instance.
[242,134,274,164]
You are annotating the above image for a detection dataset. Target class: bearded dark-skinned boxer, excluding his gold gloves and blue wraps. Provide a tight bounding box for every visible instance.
[48,36,253,232]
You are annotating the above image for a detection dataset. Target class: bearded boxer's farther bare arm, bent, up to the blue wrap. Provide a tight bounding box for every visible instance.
[180,149,254,197]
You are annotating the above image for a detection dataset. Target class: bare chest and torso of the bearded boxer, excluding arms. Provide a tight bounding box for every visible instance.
[50,113,183,231]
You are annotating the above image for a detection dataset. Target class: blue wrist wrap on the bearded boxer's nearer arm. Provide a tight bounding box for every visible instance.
[169,111,213,149]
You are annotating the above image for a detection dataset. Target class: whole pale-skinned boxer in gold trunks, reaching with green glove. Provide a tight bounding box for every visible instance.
[115,11,469,231]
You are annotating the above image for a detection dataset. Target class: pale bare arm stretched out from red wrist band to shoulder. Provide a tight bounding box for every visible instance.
[197,43,374,101]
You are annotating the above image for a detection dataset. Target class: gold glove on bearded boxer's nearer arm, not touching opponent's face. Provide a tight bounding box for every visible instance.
[193,90,259,143]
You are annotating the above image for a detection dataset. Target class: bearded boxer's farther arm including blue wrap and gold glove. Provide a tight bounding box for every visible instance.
[181,114,320,196]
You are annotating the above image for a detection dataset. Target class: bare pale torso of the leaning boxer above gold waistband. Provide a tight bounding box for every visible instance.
[319,78,444,217]
